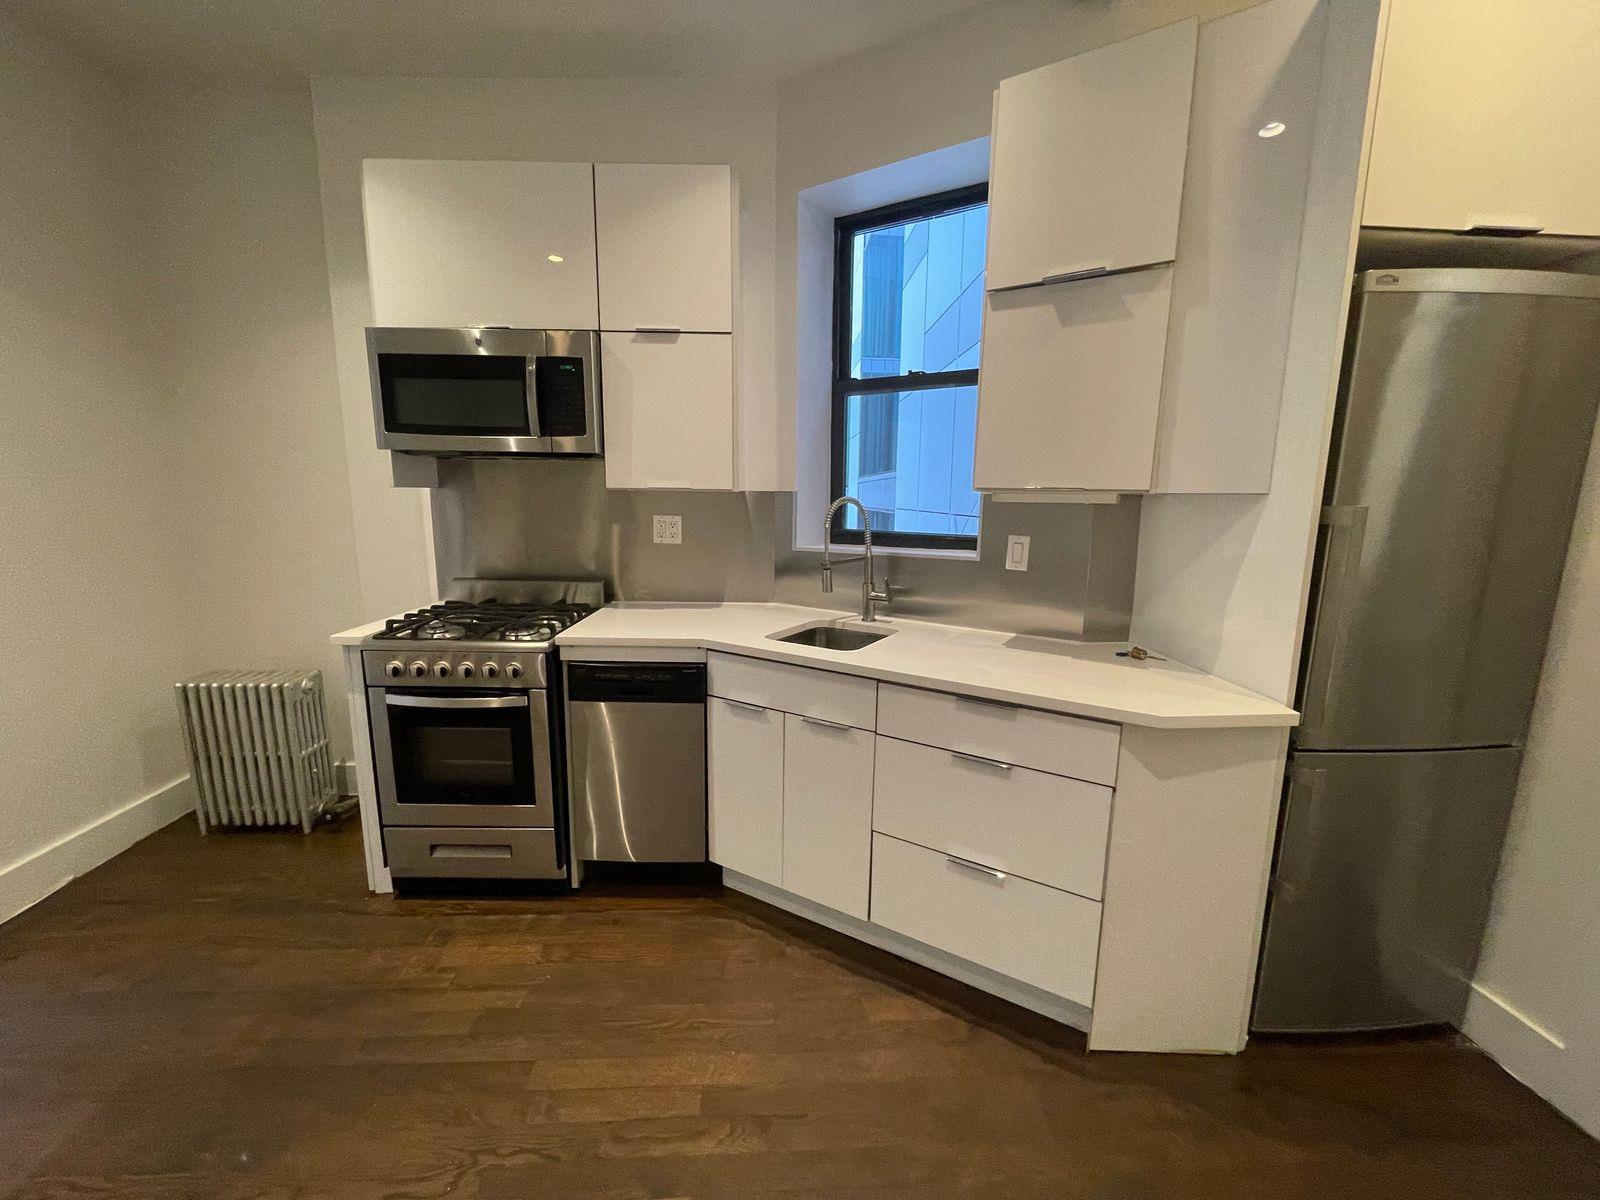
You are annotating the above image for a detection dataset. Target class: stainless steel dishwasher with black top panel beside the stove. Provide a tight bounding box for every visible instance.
[566,662,706,862]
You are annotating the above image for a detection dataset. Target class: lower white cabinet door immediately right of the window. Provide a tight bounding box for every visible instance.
[973,267,1173,491]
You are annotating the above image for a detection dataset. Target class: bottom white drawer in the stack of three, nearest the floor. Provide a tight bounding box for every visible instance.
[872,834,1101,1006]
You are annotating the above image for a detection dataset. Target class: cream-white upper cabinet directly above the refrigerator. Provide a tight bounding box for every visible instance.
[1362,0,1600,237]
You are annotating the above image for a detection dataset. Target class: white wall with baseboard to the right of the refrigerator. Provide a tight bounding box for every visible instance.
[1464,416,1600,1138]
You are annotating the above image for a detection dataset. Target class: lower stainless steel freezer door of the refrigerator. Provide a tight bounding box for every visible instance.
[1251,747,1522,1034]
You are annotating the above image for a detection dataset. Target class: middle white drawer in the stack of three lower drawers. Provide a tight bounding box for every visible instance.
[872,736,1110,899]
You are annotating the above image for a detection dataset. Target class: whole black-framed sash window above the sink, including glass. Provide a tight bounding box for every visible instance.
[830,184,989,550]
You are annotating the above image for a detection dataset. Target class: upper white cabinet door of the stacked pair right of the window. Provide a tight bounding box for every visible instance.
[984,19,1197,294]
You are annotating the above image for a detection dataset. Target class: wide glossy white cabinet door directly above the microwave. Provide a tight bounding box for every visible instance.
[362,158,600,330]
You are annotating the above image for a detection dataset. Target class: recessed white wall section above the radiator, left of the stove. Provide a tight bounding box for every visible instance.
[128,90,364,758]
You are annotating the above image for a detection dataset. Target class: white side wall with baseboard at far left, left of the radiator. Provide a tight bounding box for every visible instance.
[0,22,196,920]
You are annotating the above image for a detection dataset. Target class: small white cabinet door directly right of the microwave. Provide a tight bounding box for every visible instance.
[600,333,733,491]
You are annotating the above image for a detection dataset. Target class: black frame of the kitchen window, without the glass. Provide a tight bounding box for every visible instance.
[829,182,989,550]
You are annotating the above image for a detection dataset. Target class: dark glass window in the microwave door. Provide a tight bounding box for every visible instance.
[378,354,531,437]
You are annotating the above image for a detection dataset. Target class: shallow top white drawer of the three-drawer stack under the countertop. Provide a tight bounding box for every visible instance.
[878,683,1122,787]
